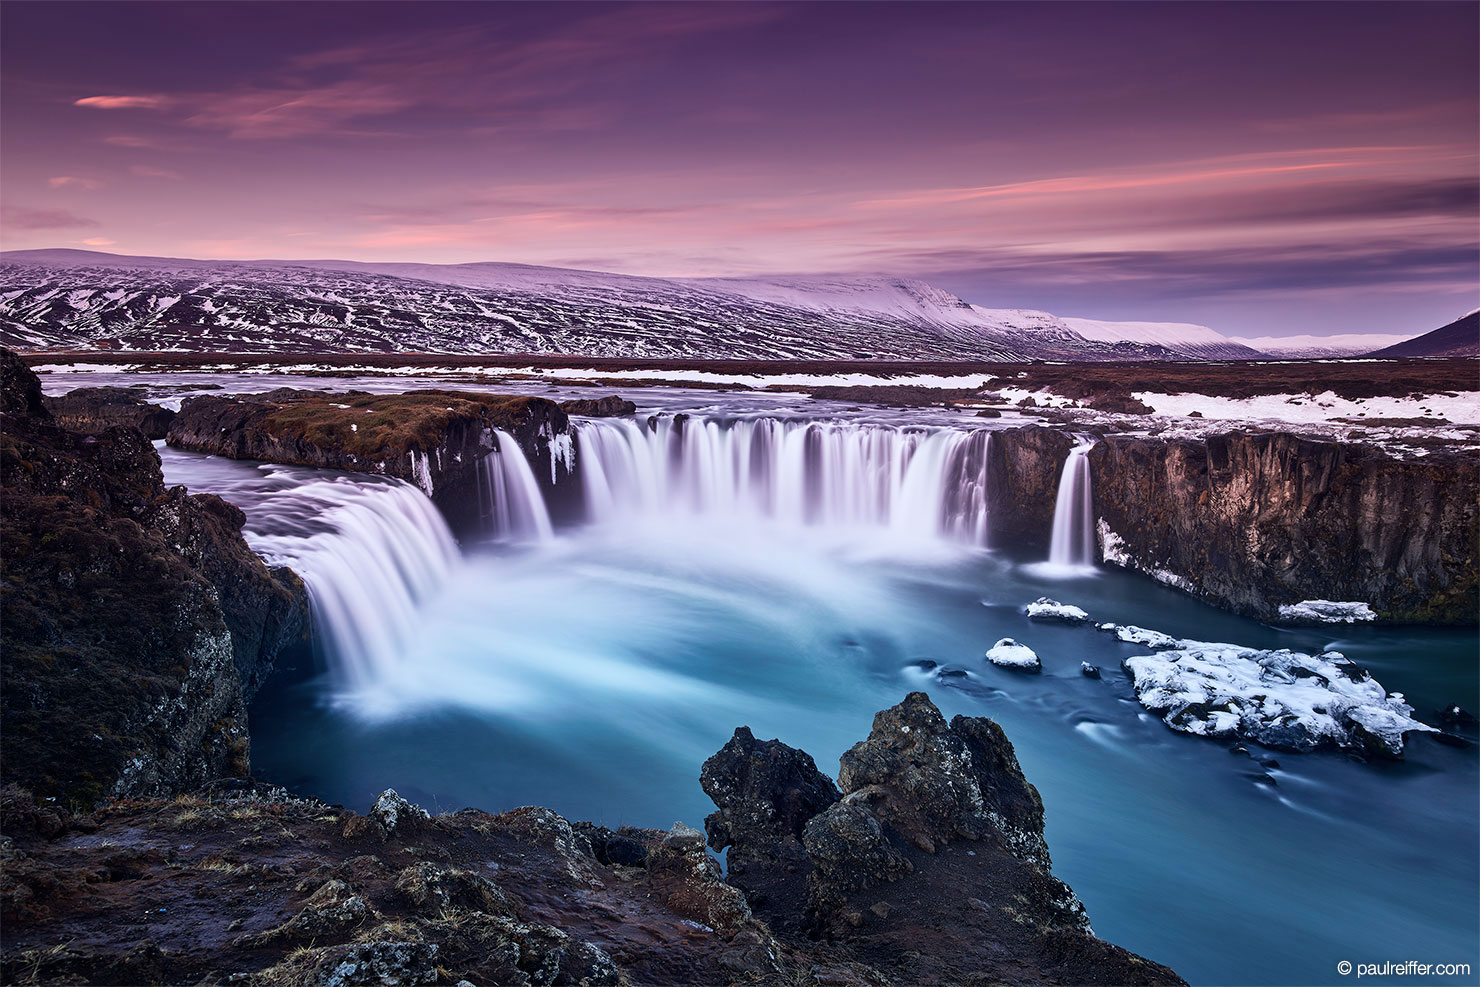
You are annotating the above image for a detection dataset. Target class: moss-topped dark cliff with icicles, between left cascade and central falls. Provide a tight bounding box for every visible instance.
[167,388,573,530]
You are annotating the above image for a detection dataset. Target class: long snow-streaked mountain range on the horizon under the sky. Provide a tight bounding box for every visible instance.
[0,250,1438,361]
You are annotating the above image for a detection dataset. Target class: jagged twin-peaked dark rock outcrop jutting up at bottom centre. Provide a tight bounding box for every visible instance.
[703,693,1181,984]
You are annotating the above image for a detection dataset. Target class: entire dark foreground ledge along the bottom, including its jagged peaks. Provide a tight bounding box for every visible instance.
[0,693,1183,987]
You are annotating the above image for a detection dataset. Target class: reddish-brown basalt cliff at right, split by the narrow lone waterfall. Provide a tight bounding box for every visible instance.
[992,428,1480,623]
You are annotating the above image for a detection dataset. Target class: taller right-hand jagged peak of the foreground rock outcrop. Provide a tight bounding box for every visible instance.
[838,693,1049,870]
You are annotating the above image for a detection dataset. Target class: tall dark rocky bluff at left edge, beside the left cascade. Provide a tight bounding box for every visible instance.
[0,351,308,805]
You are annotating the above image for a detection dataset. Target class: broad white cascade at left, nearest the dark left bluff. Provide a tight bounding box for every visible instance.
[246,474,459,684]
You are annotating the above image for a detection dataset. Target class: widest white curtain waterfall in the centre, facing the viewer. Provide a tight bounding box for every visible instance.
[577,419,990,546]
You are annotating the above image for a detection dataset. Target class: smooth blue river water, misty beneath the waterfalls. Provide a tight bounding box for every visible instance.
[49,374,1480,984]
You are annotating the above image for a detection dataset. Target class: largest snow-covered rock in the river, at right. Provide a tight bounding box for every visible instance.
[1122,635,1433,758]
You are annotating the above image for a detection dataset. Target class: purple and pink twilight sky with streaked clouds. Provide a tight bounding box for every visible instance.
[0,0,1480,336]
